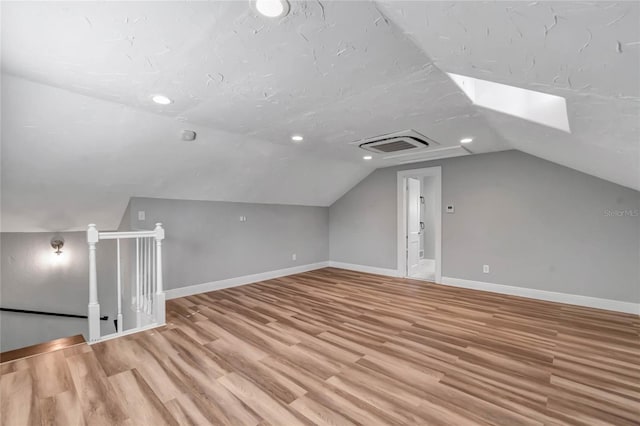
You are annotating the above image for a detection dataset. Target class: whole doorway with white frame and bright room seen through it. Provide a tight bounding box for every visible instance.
[398,167,442,283]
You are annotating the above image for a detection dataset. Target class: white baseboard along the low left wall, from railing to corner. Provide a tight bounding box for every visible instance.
[165,262,329,299]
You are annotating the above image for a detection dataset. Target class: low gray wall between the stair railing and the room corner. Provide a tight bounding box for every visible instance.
[121,198,329,289]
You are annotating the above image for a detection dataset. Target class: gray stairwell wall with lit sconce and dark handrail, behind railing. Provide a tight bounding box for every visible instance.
[0,232,116,351]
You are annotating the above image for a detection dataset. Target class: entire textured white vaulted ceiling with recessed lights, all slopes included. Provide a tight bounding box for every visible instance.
[0,1,640,231]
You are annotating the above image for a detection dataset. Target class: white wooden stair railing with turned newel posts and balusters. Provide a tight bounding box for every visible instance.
[87,223,165,342]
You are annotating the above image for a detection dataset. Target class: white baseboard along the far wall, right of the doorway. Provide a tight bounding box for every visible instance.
[442,277,640,315]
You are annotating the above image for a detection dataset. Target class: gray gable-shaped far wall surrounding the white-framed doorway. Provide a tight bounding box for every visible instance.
[329,151,640,302]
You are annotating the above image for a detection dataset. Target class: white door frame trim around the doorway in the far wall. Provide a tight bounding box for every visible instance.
[397,166,442,284]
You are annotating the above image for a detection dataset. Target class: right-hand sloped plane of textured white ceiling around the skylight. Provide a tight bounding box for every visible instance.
[381,1,640,190]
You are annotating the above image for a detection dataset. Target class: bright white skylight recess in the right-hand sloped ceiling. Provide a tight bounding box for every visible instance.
[449,73,571,133]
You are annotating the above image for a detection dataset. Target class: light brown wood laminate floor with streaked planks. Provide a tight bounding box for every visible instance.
[0,268,640,426]
